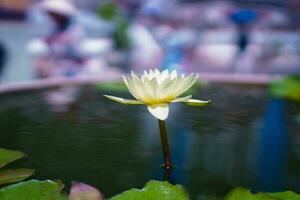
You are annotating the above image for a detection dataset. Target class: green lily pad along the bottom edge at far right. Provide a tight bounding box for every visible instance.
[224,188,300,200]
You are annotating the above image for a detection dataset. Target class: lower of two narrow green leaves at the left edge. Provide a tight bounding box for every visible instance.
[0,169,34,185]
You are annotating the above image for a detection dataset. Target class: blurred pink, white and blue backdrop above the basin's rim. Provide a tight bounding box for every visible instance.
[0,0,300,84]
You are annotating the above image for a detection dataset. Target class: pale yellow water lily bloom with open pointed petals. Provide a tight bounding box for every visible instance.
[104,69,210,120]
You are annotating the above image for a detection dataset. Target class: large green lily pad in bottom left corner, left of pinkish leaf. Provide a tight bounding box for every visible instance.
[0,180,65,200]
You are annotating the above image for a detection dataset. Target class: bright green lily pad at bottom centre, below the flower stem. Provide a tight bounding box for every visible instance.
[111,181,189,200]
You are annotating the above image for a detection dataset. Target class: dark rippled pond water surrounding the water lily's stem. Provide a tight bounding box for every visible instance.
[0,85,300,199]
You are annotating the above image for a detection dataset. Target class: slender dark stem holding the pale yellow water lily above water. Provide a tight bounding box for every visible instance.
[158,120,172,170]
